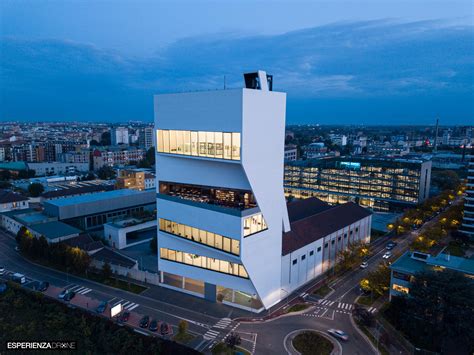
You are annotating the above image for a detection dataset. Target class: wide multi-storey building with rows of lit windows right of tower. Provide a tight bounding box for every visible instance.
[284,157,431,211]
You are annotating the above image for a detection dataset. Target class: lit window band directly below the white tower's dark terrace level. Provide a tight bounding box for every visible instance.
[159,218,240,255]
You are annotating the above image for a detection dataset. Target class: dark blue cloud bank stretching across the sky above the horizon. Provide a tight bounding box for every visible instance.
[0,20,474,122]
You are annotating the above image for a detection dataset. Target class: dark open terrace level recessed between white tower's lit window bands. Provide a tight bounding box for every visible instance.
[160,181,257,210]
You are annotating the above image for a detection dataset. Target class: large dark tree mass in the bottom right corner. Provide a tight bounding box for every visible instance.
[386,270,474,354]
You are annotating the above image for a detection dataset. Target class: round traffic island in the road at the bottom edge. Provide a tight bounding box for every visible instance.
[283,329,342,355]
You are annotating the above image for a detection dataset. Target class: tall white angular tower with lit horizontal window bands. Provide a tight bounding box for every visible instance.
[154,71,290,311]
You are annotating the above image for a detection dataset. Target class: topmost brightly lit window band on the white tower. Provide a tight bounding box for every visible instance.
[156,129,240,160]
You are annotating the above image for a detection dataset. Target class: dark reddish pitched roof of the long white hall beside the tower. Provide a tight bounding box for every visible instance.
[282,201,372,255]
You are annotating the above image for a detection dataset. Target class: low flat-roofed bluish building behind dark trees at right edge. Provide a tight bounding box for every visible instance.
[390,251,474,299]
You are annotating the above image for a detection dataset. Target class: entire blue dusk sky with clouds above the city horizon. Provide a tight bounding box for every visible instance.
[0,0,474,124]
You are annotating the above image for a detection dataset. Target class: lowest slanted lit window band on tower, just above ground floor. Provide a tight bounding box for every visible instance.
[160,248,249,279]
